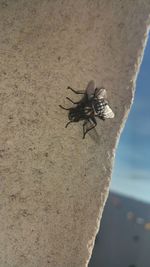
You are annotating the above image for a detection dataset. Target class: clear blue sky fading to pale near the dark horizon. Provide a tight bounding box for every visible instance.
[111,33,150,203]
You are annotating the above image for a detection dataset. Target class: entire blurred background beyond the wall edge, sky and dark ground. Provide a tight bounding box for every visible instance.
[89,34,150,267]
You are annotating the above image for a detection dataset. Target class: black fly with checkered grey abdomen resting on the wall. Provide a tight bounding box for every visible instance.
[59,81,114,139]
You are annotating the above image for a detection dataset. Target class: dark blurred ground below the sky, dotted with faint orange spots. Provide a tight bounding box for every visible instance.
[89,193,150,267]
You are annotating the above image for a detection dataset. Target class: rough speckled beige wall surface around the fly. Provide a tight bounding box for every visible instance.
[0,0,150,267]
